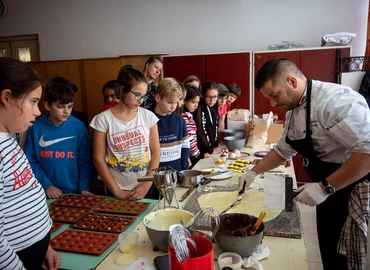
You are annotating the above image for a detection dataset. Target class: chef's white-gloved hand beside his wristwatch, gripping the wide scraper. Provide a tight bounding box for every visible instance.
[295,183,329,206]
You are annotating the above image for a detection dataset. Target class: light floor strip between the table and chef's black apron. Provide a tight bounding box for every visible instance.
[298,204,323,270]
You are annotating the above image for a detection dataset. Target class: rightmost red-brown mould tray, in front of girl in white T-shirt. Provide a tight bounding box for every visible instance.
[93,200,150,215]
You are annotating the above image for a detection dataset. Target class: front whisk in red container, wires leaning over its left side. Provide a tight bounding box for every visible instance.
[170,224,196,263]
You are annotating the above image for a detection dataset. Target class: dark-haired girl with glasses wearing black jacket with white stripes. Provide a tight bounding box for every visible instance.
[194,81,221,154]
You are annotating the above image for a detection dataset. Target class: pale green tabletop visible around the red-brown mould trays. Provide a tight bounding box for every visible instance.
[47,197,158,270]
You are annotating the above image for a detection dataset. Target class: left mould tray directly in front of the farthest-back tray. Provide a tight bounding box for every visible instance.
[49,206,90,223]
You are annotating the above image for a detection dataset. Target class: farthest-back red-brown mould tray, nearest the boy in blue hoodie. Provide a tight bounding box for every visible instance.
[51,195,105,209]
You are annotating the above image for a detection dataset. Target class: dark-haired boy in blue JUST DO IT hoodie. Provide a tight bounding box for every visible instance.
[25,82,94,199]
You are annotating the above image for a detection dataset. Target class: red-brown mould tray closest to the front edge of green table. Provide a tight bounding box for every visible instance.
[50,230,118,255]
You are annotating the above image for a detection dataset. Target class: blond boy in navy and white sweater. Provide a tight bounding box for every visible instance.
[154,78,190,171]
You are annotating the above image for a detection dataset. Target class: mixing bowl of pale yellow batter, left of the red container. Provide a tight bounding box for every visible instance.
[143,208,194,252]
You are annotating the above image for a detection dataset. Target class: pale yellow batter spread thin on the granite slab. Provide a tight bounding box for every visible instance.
[198,189,281,221]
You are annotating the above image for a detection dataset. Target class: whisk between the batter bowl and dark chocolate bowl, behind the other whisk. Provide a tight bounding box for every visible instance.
[191,206,220,250]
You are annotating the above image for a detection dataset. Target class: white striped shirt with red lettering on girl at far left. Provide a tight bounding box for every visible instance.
[0,132,51,270]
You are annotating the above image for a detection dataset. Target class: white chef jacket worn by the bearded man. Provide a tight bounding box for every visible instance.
[274,80,370,164]
